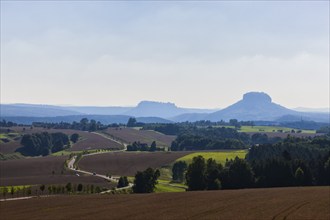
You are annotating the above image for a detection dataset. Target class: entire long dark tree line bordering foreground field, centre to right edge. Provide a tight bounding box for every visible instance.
[172,137,330,190]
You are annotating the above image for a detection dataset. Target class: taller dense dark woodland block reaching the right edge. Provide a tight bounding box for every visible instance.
[247,137,330,187]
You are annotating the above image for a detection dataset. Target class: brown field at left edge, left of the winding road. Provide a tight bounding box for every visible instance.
[0,156,112,186]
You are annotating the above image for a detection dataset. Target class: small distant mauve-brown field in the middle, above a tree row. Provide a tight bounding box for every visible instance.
[104,128,176,146]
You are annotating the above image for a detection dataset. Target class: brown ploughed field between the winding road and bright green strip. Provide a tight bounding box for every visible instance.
[79,151,192,176]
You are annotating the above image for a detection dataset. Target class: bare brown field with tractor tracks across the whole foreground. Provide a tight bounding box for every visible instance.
[0,187,330,220]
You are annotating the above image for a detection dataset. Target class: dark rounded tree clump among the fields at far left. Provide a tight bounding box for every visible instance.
[17,132,70,156]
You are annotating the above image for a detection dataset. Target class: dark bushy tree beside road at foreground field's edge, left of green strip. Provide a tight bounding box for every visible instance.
[133,167,160,193]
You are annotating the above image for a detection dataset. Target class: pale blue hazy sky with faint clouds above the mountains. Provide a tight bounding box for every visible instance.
[1,0,330,108]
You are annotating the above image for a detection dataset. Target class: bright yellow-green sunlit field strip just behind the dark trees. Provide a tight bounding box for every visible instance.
[176,150,247,165]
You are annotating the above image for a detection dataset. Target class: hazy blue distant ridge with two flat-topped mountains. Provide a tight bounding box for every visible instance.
[0,92,330,123]
